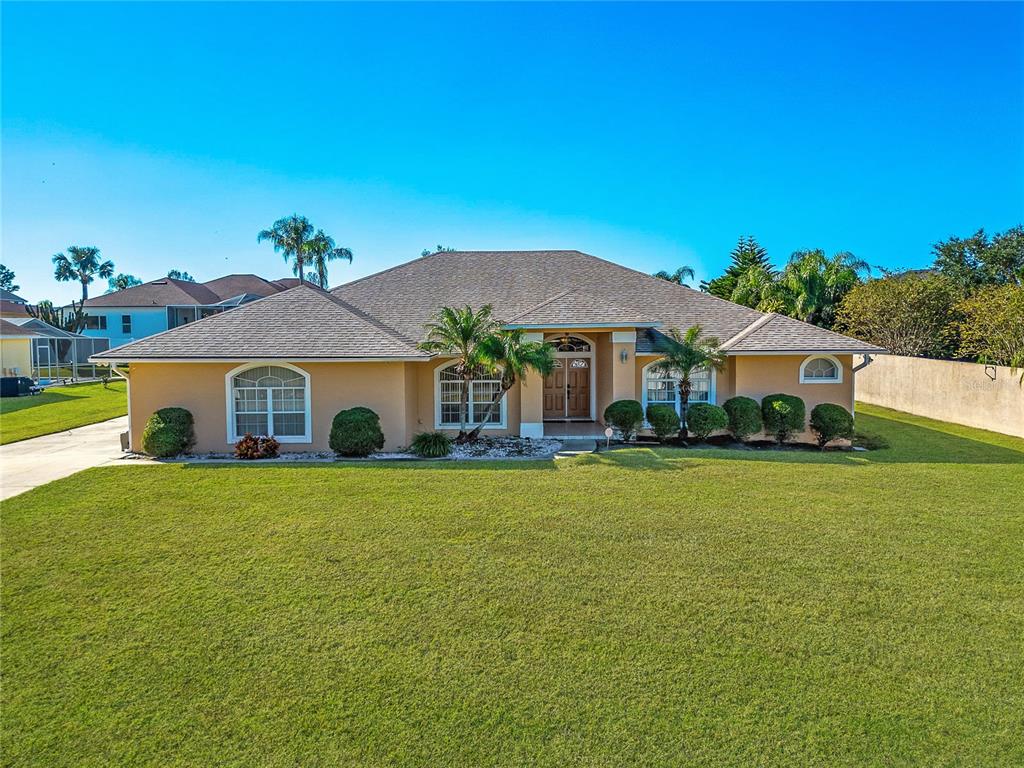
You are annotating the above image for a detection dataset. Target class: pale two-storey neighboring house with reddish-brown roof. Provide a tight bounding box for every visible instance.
[83,274,298,347]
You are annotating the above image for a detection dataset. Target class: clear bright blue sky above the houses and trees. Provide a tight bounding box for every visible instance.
[2,3,1024,300]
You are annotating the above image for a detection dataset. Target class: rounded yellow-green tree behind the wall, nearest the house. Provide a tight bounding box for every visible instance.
[836,272,958,357]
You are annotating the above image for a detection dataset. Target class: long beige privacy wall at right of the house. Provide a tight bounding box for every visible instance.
[857,354,1024,437]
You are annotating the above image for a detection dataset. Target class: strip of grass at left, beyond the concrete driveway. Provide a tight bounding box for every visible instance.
[0,380,128,445]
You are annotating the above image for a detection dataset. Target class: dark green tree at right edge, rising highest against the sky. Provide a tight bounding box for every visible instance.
[932,225,1024,295]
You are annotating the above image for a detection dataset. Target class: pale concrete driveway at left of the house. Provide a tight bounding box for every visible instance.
[0,416,128,499]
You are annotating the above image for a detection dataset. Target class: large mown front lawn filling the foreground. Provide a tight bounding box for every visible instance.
[2,407,1024,768]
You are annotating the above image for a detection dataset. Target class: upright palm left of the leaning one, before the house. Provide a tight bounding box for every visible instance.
[420,304,501,442]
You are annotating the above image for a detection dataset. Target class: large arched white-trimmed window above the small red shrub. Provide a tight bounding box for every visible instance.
[227,365,312,442]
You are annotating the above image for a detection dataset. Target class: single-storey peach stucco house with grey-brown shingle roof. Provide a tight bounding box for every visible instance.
[95,251,884,452]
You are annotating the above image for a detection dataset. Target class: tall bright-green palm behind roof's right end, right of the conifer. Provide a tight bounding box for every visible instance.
[779,249,870,328]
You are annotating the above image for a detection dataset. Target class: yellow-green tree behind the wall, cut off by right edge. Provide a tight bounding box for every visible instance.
[956,286,1024,368]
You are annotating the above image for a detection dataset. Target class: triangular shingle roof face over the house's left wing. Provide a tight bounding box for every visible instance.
[93,286,429,360]
